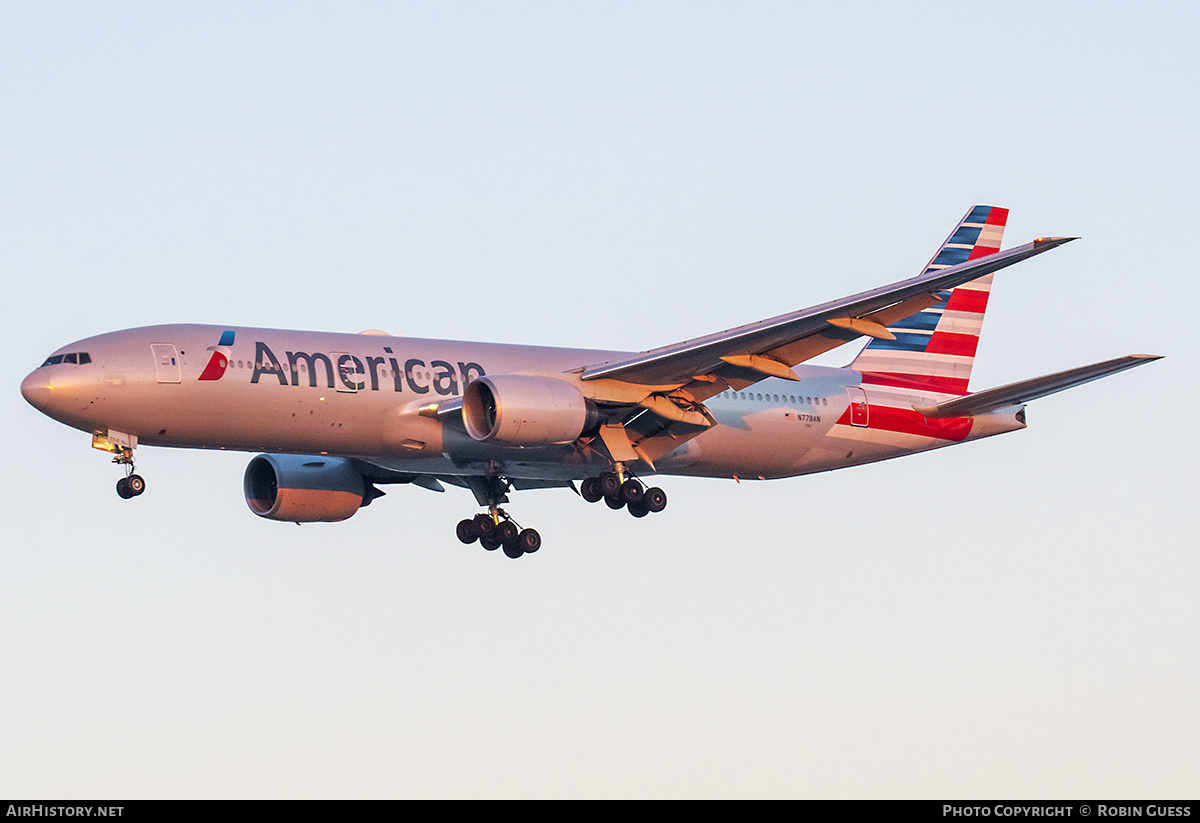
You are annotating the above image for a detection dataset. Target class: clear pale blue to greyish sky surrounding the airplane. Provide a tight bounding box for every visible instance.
[0,1,1200,798]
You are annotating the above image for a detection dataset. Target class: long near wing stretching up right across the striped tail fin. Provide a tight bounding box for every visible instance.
[580,232,1075,391]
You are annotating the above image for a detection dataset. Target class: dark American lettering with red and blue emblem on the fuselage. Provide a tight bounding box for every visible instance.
[246,332,484,396]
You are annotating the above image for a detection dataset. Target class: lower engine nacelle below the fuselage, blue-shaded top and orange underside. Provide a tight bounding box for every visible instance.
[242,455,367,523]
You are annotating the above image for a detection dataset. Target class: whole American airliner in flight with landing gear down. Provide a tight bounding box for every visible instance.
[20,205,1158,558]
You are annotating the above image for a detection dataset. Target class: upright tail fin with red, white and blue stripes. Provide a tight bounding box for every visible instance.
[850,205,1008,395]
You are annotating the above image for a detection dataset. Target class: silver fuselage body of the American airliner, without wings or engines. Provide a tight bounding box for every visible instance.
[22,325,1024,480]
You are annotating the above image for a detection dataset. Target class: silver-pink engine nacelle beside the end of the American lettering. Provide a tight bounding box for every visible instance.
[462,374,599,446]
